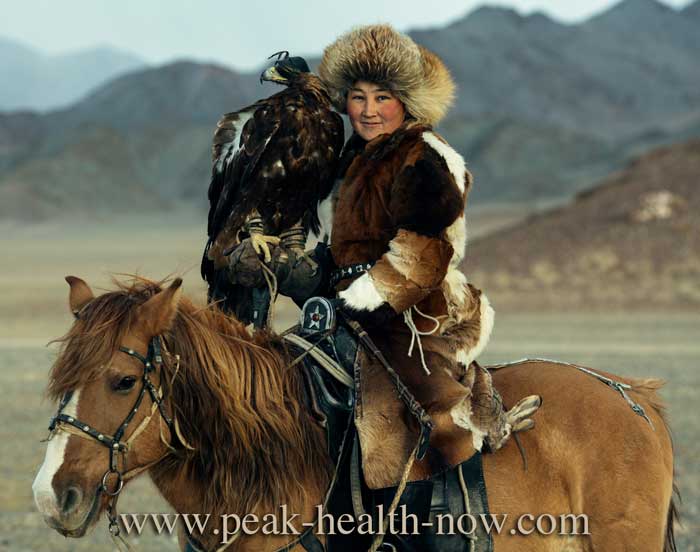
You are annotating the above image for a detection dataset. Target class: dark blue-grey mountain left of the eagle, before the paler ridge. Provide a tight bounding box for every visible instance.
[0,62,262,220]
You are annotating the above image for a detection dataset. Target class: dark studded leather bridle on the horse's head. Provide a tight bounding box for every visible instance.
[49,336,178,537]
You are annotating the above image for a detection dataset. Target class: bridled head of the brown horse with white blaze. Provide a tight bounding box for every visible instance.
[33,276,182,537]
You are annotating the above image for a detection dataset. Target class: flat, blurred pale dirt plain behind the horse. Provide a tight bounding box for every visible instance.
[0,213,700,552]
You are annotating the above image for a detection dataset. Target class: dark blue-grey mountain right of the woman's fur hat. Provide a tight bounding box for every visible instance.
[410,0,700,201]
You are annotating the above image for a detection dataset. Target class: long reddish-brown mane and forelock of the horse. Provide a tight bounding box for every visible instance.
[48,278,330,514]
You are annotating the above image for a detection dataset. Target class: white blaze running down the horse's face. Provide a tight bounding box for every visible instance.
[32,390,80,518]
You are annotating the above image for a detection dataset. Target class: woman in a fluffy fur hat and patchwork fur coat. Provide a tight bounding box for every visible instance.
[232,25,539,488]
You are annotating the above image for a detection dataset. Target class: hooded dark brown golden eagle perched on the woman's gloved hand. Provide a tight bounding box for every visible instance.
[202,52,344,326]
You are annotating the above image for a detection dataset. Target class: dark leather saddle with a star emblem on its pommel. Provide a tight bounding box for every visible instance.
[285,297,493,552]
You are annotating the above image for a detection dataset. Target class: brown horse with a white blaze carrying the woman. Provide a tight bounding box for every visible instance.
[34,277,676,552]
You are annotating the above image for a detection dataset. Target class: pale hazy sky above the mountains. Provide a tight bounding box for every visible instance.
[0,0,689,69]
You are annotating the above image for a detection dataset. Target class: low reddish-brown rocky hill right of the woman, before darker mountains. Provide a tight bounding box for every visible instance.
[464,140,700,309]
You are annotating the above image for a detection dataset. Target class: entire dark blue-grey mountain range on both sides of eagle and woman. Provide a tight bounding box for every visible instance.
[0,0,700,218]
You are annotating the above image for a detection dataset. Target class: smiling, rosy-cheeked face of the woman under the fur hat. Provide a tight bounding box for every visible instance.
[346,81,406,141]
